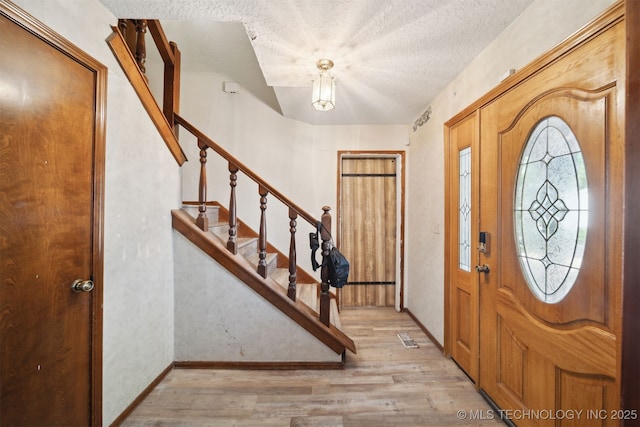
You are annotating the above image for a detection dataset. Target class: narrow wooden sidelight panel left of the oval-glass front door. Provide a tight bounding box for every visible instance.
[445,112,479,381]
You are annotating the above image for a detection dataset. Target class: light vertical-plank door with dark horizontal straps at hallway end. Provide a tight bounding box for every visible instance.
[340,156,397,307]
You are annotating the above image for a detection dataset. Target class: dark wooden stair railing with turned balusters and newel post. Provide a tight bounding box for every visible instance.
[174,113,331,326]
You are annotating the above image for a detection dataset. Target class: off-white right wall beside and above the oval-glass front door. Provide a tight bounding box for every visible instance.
[405,0,613,344]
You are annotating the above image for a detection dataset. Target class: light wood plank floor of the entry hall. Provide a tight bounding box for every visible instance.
[123,308,501,427]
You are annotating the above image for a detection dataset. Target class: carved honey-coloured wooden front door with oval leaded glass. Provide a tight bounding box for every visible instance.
[479,14,625,426]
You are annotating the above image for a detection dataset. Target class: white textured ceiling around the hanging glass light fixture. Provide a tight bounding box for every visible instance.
[101,0,532,124]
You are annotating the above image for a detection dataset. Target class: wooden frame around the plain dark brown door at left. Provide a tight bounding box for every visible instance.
[0,2,107,425]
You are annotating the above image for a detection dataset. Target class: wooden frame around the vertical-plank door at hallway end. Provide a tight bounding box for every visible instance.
[336,150,406,311]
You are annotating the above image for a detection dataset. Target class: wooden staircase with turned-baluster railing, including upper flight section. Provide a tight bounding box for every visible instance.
[107,19,356,354]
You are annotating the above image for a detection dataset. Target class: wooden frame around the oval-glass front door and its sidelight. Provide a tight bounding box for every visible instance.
[444,0,640,416]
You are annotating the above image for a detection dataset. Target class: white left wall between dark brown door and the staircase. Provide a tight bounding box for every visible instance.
[15,0,180,425]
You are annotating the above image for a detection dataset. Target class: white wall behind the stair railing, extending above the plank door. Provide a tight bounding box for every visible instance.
[175,71,408,280]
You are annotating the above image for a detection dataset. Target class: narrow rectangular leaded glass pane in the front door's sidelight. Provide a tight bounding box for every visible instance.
[458,147,471,271]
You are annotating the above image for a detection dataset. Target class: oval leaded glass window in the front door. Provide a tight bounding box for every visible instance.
[514,116,589,304]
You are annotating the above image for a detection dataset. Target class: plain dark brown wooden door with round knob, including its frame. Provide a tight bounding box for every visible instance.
[0,5,106,426]
